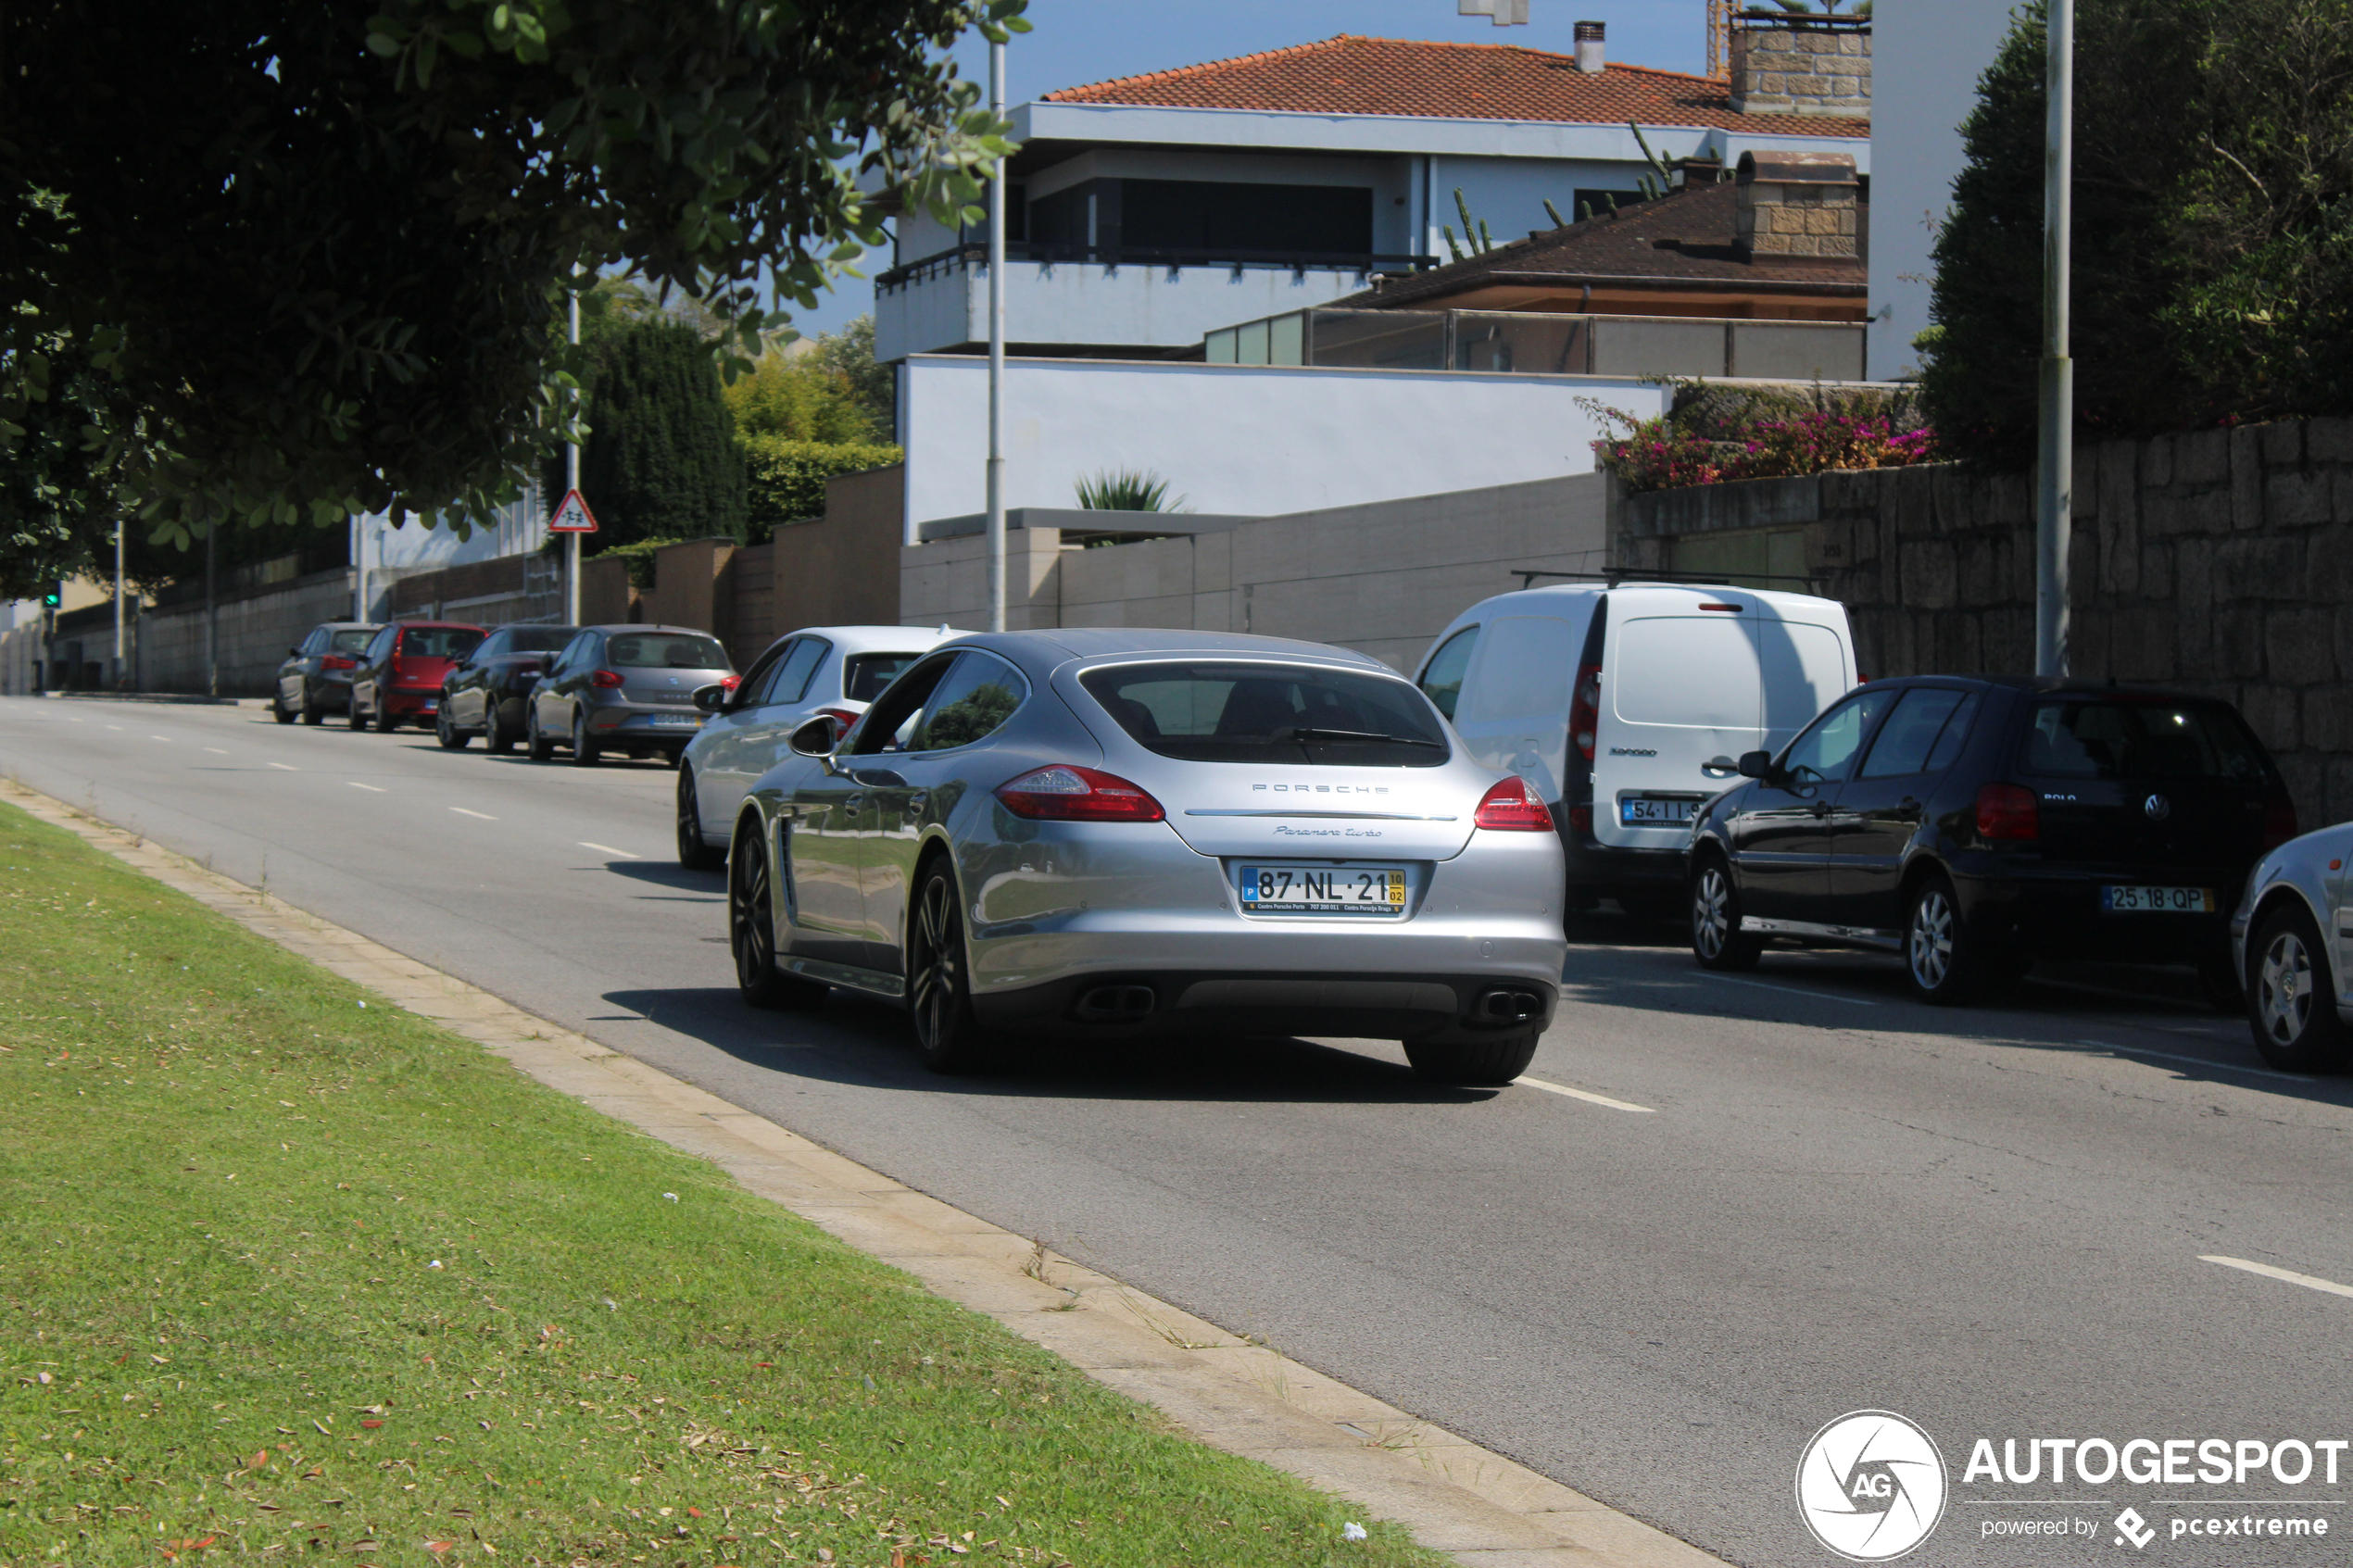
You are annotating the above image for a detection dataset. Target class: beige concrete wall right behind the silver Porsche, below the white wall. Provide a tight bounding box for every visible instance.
[899,475,1607,670]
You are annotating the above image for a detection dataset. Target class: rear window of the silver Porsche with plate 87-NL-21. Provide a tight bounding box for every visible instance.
[1077,663,1450,769]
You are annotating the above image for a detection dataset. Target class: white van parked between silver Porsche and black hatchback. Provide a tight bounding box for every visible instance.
[1415,581,1856,914]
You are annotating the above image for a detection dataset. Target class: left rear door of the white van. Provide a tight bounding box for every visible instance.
[1593,588,1769,848]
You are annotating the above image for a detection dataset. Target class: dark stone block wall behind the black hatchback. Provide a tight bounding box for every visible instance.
[1612,419,2353,827]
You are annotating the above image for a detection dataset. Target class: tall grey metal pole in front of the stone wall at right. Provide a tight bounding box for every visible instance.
[2035,0,2075,674]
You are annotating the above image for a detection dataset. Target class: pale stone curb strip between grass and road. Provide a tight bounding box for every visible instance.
[0,781,1720,1568]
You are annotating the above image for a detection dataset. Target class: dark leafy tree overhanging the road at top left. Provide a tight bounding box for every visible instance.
[0,0,1026,596]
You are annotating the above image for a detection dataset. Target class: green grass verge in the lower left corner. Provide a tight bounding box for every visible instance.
[0,807,1445,1568]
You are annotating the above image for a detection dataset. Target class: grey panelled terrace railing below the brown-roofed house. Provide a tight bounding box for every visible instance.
[1202,310,1866,381]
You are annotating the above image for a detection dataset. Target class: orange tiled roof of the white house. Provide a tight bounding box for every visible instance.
[1042,33,1870,136]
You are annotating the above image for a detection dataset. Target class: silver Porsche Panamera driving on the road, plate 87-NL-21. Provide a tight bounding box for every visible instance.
[727,630,1567,1084]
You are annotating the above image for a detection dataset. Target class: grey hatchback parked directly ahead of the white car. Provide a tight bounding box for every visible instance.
[524,625,736,766]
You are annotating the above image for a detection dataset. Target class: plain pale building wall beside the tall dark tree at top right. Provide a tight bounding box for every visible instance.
[1866,0,2012,381]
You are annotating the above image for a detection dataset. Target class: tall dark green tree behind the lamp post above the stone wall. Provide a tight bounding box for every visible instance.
[1920,0,2353,468]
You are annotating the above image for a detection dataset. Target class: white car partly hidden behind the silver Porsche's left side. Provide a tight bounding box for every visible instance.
[678,625,958,870]
